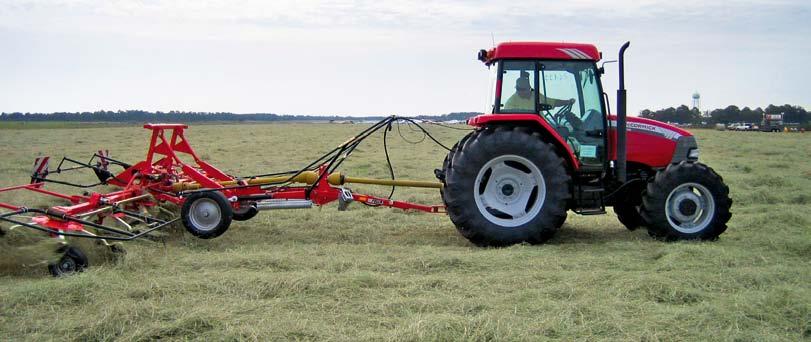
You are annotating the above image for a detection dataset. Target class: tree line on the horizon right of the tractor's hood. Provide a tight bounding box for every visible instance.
[639,104,811,125]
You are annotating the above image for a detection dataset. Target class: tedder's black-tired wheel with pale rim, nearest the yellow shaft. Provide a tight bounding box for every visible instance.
[180,191,233,239]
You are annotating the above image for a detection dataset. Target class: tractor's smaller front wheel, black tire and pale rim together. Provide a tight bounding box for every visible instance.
[642,161,732,241]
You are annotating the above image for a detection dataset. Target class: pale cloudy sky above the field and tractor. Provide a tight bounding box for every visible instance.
[0,0,811,116]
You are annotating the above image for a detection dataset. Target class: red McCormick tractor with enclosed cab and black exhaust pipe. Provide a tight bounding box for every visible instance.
[437,42,732,246]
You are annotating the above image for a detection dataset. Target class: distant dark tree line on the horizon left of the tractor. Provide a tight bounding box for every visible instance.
[0,110,479,122]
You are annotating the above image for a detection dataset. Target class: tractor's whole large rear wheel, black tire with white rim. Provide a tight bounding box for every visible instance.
[442,126,570,246]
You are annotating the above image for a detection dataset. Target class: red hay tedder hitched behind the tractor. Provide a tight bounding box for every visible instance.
[0,117,445,275]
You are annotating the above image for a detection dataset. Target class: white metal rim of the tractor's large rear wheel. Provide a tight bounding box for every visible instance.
[473,154,546,227]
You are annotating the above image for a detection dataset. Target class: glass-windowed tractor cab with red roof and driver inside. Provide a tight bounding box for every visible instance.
[479,42,608,172]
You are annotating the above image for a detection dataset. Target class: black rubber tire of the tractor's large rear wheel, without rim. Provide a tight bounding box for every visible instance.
[442,126,571,246]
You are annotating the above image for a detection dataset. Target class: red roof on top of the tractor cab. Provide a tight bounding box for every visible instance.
[479,42,600,65]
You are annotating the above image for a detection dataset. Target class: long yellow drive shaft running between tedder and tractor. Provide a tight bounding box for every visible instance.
[167,171,442,192]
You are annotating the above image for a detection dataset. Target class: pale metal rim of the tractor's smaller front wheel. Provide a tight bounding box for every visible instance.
[665,183,715,234]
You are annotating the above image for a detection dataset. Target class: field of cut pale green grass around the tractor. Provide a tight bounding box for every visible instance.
[0,124,811,341]
